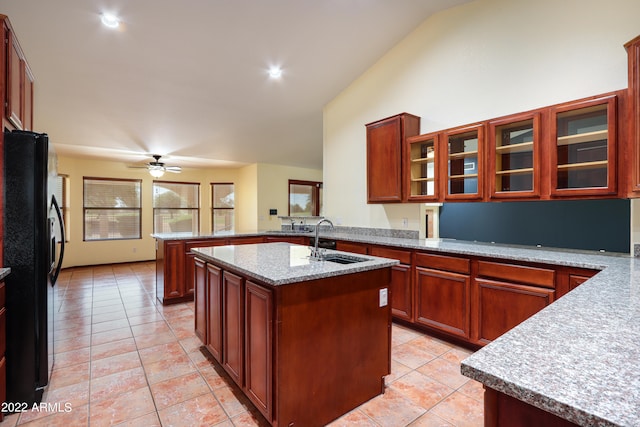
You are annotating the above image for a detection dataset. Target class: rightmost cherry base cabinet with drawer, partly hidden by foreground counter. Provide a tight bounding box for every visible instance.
[473,261,556,344]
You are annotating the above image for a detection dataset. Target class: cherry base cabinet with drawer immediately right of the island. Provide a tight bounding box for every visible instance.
[369,246,414,322]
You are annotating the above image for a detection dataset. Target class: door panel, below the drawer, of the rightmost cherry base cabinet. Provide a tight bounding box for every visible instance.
[475,279,555,344]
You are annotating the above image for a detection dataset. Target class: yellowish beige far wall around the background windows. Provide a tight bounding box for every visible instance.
[58,156,322,267]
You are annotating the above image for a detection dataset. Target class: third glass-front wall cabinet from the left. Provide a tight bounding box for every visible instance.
[488,114,540,198]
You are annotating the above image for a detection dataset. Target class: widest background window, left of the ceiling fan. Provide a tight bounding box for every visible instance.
[84,178,142,240]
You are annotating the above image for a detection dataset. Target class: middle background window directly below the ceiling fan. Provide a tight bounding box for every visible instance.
[153,181,200,233]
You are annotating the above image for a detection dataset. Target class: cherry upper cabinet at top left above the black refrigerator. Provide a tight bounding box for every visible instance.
[0,15,34,130]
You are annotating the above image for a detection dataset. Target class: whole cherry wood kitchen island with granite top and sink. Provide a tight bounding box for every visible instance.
[192,243,398,427]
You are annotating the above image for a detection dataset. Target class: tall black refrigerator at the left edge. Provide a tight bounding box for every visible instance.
[3,131,64,405]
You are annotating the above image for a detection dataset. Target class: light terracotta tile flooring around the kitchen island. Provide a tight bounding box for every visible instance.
[0,262,483,427]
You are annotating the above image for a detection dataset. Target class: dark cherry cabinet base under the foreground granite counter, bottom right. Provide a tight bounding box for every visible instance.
[484,386,577,427]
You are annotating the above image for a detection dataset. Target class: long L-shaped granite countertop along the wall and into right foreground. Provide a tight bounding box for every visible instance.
[158,232,640,426]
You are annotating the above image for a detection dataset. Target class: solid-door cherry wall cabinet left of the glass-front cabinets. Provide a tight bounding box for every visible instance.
[366,113,420,203]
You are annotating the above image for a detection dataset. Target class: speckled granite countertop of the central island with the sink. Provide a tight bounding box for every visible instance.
[191,243,398,286]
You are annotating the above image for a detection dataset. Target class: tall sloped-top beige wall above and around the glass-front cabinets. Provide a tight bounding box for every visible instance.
[323,0,640,247]
